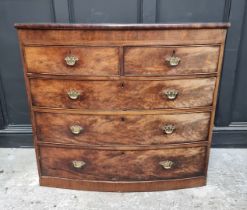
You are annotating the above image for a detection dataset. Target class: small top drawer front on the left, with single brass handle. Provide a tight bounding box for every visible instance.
[25,46,119,76]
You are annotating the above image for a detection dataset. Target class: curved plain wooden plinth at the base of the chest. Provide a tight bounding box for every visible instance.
[40,176,206,192]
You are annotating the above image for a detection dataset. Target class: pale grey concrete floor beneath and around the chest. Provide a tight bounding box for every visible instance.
[0,148,247,210]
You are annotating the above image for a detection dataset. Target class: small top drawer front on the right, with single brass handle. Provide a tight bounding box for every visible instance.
[124,46,219,76]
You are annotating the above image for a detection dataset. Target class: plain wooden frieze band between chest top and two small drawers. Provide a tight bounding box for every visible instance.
[19,28,226,46]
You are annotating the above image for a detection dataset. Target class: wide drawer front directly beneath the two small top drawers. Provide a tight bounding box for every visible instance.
[30,78,215,110]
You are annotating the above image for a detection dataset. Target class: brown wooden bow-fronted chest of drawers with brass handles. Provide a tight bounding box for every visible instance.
[16,23,229,191]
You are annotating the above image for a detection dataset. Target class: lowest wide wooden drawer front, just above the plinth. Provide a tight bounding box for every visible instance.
[40,146,206,181]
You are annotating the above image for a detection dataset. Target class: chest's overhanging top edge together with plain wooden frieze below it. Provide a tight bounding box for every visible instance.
[16,23,229,45]
